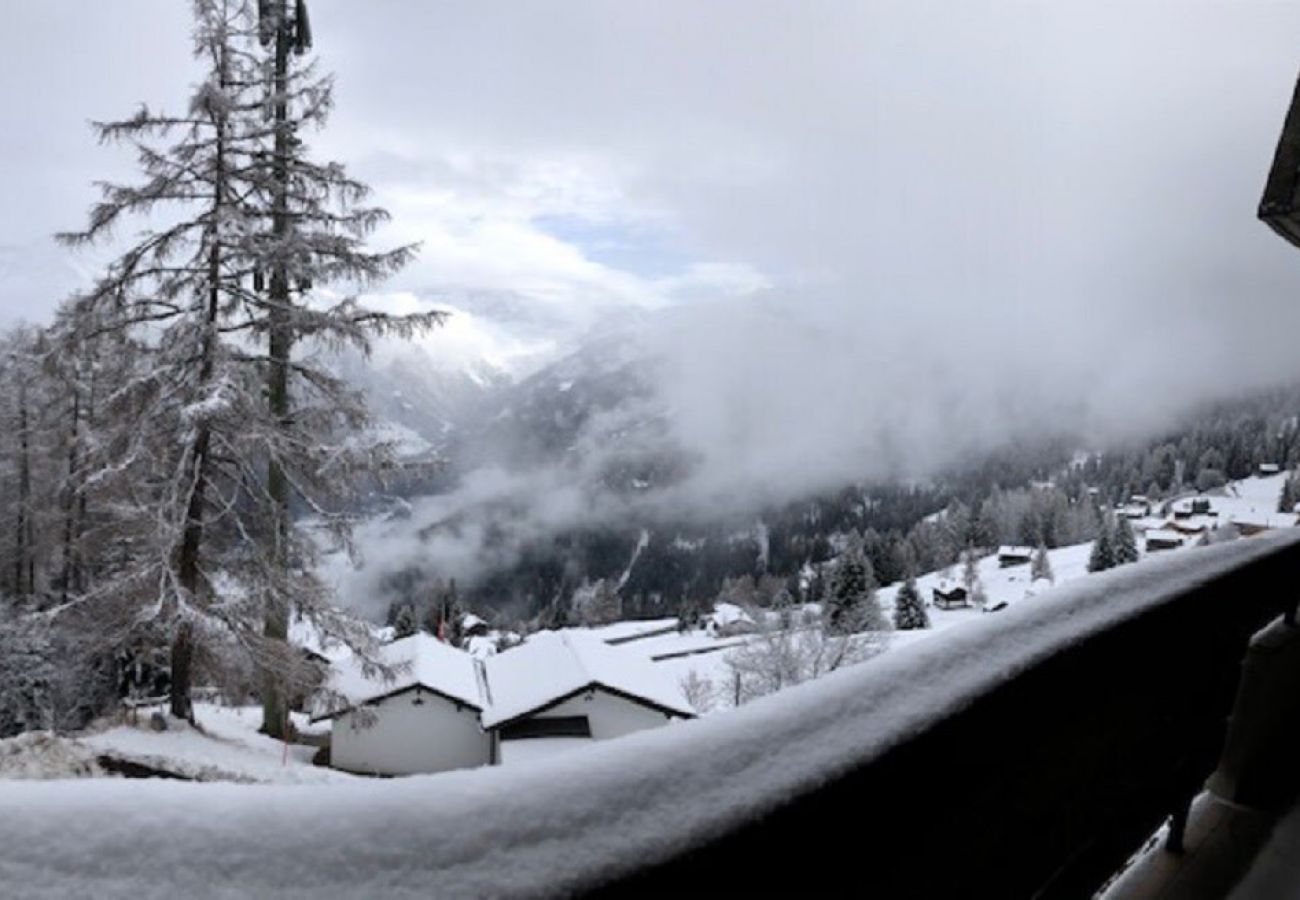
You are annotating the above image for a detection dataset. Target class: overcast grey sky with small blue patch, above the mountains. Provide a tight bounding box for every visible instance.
[0,0,1300,499]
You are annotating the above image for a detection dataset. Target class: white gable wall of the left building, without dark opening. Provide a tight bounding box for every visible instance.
[330,688,491,775]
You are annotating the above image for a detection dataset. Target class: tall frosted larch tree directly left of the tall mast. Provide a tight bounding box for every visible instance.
[55,0,441,723]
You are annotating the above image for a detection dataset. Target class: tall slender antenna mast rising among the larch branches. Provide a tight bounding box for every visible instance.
[257,0,312,737]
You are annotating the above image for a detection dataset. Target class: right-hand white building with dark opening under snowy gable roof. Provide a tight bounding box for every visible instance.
[482,631,696,762]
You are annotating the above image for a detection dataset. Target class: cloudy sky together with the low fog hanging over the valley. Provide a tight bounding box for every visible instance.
[0,0,1300,611]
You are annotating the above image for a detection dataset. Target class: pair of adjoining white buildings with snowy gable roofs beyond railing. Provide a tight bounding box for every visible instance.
[313,632,696,775]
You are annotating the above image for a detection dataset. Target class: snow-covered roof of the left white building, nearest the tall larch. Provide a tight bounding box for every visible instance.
[316,632,488,718]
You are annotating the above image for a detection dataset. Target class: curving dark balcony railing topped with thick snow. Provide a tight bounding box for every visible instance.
[10,532,1300,897]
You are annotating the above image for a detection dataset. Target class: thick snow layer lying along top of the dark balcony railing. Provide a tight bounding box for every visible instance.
[0,532,1300,900]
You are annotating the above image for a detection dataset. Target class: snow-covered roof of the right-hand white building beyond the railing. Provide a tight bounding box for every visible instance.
[482,631,696,728]
